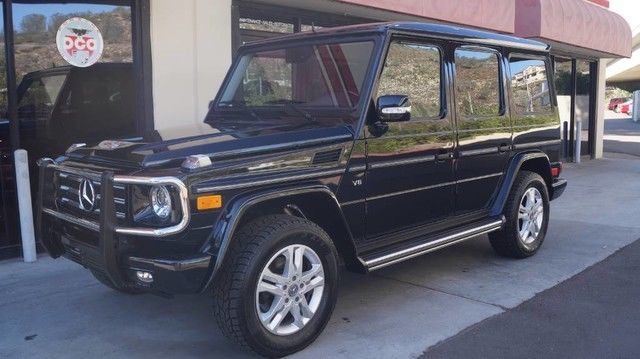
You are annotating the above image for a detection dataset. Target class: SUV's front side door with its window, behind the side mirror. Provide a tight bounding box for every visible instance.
[366,38,455,243]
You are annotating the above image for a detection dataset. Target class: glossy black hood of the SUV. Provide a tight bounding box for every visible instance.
[67,124,354,167]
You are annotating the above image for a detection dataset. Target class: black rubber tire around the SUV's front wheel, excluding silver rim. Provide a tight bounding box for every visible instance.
[213,215,339,357]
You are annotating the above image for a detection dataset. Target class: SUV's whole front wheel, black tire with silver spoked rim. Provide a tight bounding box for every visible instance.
[213,215,338,357]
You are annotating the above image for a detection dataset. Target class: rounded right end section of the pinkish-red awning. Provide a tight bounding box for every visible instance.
[515,0,631,57]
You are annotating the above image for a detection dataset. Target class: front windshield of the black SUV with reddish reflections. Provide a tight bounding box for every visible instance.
[219,41,373,108]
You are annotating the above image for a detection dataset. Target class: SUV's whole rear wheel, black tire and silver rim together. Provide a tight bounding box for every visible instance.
[489,171,549,258]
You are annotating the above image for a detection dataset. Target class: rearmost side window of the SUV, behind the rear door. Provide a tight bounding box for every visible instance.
[509,56,551,115]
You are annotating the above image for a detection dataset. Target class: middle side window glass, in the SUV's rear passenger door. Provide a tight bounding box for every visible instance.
[455,49,500,116]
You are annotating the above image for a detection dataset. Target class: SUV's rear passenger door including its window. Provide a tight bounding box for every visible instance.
[454,46,512,215]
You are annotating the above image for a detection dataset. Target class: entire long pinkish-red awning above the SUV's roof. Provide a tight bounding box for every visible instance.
[336,0,631,57]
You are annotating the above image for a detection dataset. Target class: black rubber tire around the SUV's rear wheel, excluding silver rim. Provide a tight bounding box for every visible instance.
[489,171,549,258]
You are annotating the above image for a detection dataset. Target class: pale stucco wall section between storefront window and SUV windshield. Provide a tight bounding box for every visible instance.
[151,0,232,132]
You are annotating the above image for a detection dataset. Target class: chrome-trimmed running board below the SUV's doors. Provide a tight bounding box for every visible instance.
[360,216,505,271]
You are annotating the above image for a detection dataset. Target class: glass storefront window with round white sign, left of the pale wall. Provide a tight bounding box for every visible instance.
[0,0,138,257]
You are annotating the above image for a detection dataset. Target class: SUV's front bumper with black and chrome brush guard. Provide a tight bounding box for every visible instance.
[36,161,212,294]
